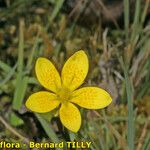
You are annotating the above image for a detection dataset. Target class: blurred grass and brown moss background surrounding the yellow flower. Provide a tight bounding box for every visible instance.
[0,0,150,150]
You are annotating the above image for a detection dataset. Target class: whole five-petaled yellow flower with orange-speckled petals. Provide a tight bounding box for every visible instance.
[26,50,112,132]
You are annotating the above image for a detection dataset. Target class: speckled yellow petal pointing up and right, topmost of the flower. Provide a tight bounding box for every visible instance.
[61,50,89,91]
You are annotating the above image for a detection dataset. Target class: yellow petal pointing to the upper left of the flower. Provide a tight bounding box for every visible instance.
[35,58,61,92]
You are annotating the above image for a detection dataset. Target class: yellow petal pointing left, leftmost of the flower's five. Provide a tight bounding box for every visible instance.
[25,91,60,113]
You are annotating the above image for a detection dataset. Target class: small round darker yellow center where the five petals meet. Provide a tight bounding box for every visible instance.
[57,88,71,103]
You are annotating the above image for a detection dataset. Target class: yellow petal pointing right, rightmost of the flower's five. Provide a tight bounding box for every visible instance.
[70,87,112,109]
